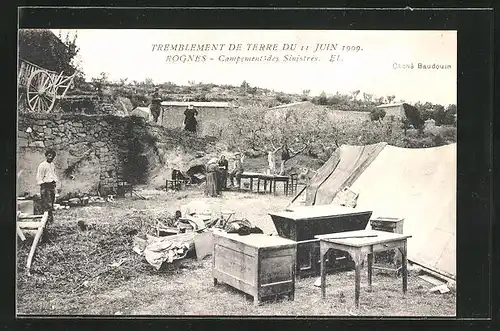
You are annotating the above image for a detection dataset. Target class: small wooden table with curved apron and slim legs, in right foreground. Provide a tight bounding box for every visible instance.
[315,230,411,307]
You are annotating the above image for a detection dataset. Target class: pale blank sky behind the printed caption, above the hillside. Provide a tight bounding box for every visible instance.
[52,29,457,105]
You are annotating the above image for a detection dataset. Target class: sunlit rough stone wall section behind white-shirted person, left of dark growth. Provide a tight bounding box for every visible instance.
[18,114,129,196]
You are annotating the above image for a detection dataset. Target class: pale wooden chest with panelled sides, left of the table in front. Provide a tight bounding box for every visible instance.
[213,231,297,305]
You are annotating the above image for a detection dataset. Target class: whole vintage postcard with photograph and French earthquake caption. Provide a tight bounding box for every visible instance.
[16,29,457,317]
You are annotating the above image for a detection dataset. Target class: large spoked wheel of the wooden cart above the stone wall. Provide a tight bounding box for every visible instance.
[26,70,56,113]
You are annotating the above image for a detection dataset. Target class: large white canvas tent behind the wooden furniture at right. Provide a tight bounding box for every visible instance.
[306,143,456,279]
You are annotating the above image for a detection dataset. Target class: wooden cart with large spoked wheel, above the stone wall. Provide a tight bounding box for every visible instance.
[17,59,76,113]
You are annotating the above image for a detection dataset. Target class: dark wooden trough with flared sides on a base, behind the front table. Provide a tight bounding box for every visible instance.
[269,205,372,276]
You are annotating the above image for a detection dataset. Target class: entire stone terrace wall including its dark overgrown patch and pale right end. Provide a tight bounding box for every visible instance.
[17,113,219,194]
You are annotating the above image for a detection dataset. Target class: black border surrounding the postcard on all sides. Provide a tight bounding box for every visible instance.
[0,1,498,329]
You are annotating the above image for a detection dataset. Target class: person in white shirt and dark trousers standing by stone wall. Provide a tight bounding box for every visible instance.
[36,149,58,223]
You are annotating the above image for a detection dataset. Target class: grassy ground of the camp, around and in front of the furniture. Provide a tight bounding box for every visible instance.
[17,190,455,316]
